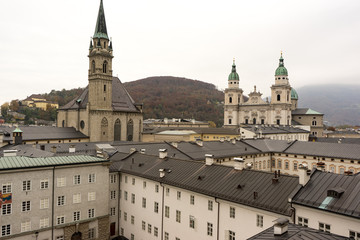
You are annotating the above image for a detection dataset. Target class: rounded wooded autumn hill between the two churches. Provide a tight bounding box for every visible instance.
[124,77,224,126]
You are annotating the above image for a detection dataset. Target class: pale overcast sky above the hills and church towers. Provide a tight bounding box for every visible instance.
[0,0,360,104]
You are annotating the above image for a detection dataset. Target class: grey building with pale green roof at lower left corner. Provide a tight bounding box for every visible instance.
[0,155,109,240]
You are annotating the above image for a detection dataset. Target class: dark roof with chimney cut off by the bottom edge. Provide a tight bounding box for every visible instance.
[248,223,348,240]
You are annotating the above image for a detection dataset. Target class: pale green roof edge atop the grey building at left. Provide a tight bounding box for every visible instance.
[0,155,109,170]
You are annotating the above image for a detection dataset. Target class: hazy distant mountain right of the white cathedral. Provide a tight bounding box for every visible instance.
[296,85,360,126]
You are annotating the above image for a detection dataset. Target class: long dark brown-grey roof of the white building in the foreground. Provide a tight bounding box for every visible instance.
[111,153,299,216]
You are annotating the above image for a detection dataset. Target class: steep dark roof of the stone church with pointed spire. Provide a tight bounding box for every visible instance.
[59,77,140,113]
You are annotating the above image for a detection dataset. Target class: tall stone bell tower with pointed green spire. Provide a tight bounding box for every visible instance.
[88,0,113,110]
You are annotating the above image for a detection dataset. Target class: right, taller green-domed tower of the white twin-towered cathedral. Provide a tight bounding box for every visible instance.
[271,53,291,125]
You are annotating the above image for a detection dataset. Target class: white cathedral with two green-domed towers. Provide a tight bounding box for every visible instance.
[224,54,323,137]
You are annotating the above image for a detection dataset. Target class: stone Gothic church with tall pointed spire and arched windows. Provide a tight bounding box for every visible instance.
[57,0,143,142]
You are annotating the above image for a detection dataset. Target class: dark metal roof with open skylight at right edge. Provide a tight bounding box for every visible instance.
[292,170,360,219]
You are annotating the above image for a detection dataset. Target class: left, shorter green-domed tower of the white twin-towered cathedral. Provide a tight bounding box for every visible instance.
[224,59,243,126]
